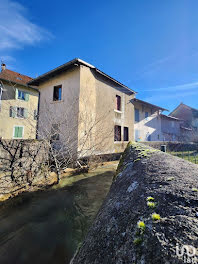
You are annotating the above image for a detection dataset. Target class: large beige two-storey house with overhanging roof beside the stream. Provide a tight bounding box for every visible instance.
[29,59,135,156]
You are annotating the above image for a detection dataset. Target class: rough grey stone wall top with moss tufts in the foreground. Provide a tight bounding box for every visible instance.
[71,143,198,264]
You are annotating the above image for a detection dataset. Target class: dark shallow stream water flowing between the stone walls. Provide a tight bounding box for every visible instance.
[0,162,117,264]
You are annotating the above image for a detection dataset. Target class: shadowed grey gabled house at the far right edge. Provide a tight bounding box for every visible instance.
[170,103,198,142]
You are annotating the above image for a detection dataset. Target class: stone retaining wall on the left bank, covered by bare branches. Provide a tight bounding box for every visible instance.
[0,139,55,199]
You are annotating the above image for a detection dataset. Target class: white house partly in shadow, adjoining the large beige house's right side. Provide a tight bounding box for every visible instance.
[133,98,166,141]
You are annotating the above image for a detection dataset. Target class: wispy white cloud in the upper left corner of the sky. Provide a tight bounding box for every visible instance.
[0,0,52,51]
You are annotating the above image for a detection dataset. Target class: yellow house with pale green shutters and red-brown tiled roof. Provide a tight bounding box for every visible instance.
[0,64,39,139]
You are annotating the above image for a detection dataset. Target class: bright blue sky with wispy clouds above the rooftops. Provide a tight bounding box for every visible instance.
[0,0,198,110]
